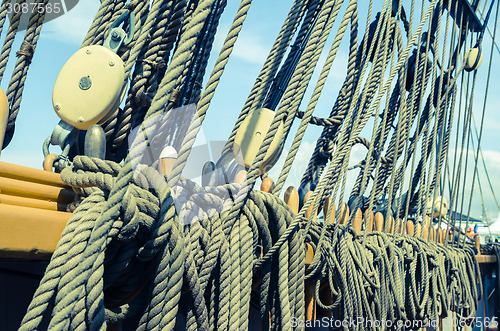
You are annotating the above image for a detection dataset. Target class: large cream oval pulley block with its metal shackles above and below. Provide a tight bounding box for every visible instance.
[44,10,135,169]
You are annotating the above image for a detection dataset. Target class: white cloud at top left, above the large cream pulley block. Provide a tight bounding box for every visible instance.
[42,0,99,45]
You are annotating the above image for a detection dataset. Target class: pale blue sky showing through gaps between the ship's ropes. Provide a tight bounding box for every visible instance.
[0,0,500,226]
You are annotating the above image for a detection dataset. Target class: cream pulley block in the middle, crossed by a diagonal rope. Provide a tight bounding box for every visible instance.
[233,108,283,173]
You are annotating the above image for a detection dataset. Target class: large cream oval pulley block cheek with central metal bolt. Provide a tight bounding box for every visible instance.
[52,45,125,130]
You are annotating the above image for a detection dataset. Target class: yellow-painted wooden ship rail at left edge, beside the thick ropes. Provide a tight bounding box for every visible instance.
[0,162,76,259]
